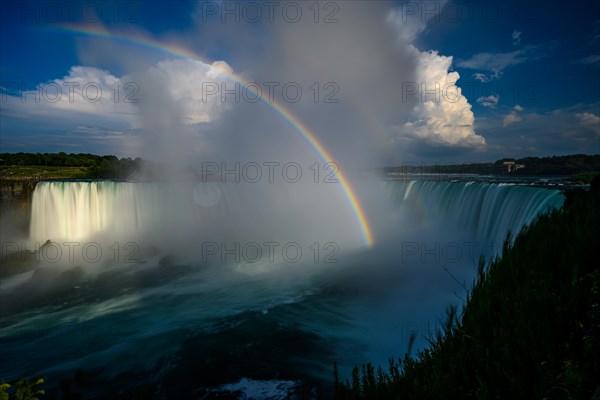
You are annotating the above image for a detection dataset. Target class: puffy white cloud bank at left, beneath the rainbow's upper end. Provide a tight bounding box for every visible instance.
[2,60,233,129]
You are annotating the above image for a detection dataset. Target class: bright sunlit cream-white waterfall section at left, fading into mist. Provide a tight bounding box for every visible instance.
[30,181,248,242]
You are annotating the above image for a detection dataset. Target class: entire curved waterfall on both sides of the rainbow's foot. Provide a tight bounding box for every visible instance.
[30,181,563,258]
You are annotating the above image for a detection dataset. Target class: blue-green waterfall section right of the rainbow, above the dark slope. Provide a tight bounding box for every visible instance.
[386,181,564,246]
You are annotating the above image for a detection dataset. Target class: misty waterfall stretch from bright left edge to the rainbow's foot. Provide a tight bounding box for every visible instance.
[30,181,361,250]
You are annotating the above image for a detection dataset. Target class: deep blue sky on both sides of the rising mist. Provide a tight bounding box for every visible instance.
[0,0,600,163]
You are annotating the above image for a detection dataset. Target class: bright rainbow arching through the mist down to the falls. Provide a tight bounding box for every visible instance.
[48,24,374,247]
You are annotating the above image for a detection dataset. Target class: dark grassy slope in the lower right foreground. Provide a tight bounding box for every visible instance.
[334,177,600,399]
